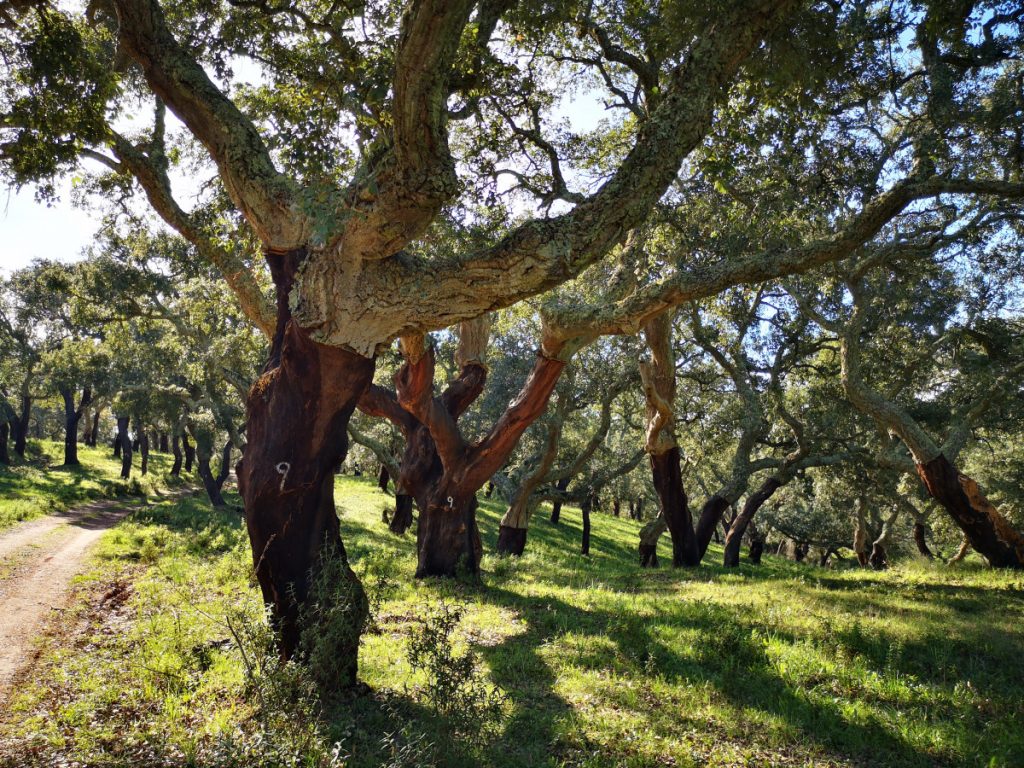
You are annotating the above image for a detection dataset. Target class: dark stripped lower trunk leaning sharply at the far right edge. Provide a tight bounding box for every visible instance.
[918,454,1024,568]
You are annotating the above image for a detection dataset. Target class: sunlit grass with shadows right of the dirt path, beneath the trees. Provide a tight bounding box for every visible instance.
[0,478,1024,768]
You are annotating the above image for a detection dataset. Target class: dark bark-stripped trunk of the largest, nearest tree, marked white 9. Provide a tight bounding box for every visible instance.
[236,253,375,686]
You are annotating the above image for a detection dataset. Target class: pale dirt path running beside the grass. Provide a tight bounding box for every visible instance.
[0,501,136,702]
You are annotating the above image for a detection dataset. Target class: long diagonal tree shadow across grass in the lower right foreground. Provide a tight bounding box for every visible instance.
[480,588,962,766]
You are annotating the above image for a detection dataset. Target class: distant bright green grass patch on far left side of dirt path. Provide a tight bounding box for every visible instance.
[0,440,171,530]
